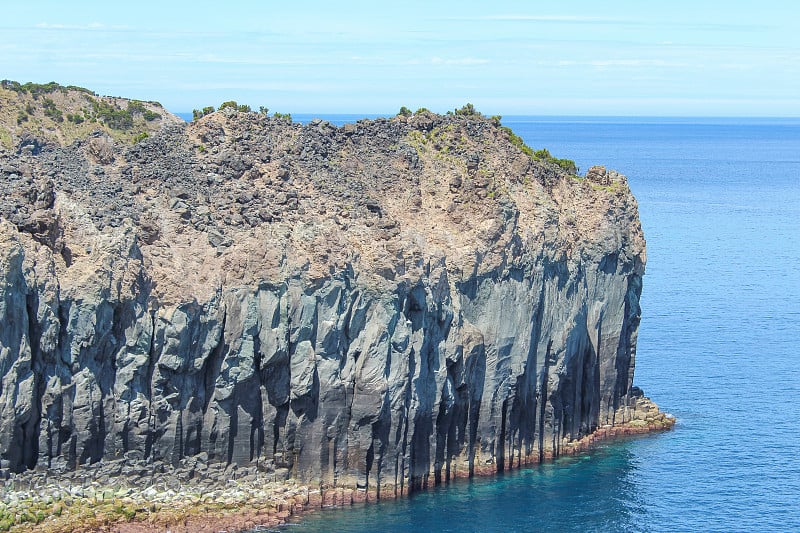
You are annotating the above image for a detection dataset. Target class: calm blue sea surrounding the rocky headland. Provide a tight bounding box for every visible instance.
[239,116,800,533]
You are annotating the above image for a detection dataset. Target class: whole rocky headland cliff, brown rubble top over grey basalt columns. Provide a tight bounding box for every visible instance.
[0,86,660,495]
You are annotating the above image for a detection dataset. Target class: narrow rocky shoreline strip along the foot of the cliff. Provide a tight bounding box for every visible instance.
[0,396,676,533]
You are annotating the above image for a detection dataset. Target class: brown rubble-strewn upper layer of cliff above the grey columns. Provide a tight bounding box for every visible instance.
[0,81,644,301]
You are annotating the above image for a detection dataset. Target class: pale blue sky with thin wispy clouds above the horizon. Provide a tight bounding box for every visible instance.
[0,0,800,117]
